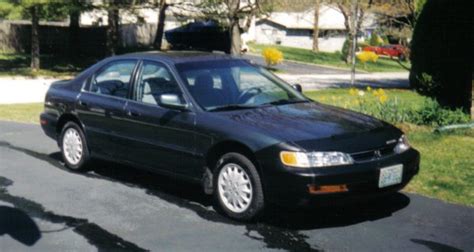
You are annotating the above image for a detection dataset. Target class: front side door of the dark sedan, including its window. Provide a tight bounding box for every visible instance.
[122,61,202,177]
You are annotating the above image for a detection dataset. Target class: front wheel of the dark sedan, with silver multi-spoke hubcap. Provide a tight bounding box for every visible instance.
[213,152,265,221]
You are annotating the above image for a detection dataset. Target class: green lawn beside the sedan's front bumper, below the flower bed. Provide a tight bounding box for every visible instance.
[405,129,474,206]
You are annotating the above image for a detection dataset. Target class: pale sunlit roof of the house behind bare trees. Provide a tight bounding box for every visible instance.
[260,5,375,30]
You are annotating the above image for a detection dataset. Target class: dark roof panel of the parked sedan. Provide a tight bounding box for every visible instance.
[115,51,244,64]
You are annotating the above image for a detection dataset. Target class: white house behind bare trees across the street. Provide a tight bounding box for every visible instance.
[244,5,375,52]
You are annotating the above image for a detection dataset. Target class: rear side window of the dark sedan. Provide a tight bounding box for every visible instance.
[90,60,137,98]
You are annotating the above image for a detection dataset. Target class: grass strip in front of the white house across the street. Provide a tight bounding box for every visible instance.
[249,43,410,72]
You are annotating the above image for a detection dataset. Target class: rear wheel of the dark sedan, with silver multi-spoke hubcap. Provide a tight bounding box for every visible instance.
[59,122,90,171]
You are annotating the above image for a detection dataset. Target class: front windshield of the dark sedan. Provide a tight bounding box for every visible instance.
[176,60,307,111]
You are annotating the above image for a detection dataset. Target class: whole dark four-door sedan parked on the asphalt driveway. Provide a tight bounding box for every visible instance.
[40,52,420,221]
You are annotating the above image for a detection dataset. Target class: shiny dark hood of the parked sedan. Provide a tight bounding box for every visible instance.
[213,102,400,152]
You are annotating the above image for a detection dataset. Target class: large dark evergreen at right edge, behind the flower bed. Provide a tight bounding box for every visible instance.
[410,0,474,113]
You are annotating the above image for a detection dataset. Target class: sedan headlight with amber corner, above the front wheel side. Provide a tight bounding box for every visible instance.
[280,151,354,168]
